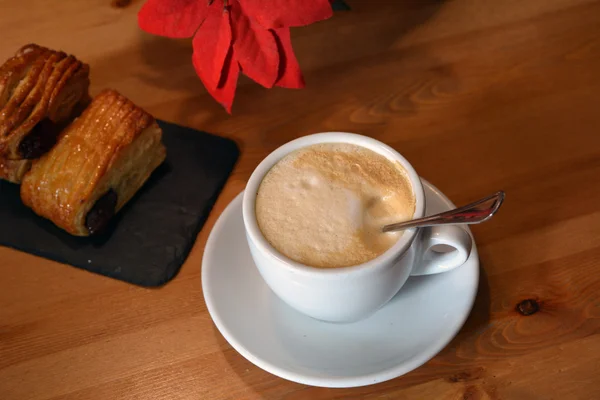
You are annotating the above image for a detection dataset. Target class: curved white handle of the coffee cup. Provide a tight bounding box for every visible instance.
[410,225,473,276]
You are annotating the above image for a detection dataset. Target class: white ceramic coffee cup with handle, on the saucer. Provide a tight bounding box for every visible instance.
[243,132,472,322]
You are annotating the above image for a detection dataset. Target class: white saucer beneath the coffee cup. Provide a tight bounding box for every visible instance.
[202,181,479,387]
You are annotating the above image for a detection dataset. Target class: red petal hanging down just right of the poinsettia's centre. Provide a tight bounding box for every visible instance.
[231,2,279,88]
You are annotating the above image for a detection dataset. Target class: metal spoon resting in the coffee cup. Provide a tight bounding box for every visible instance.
[381,190,504,232]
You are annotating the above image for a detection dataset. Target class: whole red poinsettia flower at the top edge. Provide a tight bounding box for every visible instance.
[138,0,332,112]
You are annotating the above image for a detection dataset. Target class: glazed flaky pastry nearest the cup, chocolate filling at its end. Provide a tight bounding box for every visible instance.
[21,90,166,236]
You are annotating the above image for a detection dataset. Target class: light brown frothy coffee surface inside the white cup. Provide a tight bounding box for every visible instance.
[256,143,415,268]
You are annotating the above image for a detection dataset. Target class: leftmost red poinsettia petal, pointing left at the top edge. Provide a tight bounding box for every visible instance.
[138,0,208,38]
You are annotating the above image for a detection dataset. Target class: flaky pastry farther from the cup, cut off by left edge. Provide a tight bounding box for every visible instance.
[0,44,90,160]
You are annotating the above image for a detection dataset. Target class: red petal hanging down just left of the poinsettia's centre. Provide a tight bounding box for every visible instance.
[192,4,231,91]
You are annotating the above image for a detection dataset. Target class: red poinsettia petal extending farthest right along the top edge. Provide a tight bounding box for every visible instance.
[239,0,333,29]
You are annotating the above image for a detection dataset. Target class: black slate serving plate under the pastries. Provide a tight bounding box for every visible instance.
[0,121,239,286]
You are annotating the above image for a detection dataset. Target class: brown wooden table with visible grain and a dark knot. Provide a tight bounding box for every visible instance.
[0,0,600,400]
